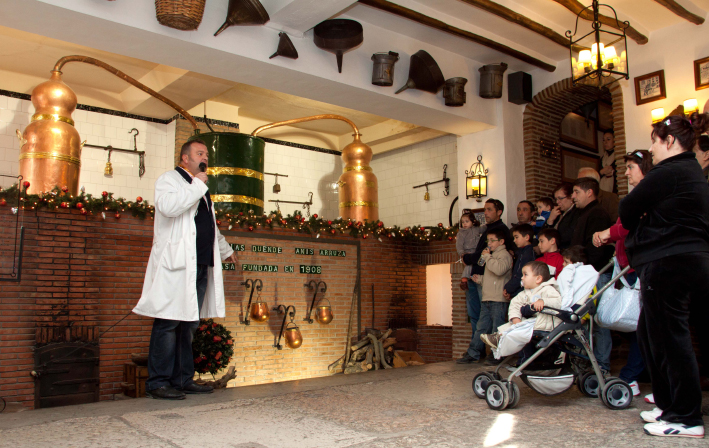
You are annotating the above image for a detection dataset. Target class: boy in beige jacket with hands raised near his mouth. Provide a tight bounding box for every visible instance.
[468,228,512,362]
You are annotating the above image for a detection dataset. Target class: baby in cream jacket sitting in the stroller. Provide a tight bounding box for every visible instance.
[480,261,561,349]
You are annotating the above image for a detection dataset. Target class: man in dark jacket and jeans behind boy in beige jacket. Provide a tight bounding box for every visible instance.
[457,199,513,364]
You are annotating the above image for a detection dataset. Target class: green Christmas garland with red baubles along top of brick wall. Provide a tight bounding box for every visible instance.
[0,181,458,242]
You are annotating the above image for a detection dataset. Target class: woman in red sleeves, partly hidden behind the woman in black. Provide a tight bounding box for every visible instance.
[593,150,653,396]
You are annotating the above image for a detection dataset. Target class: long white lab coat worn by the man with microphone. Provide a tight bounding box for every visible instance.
[133,170,234,321]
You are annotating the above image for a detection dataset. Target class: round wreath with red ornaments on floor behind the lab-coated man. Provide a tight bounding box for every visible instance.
[192,319,234,376]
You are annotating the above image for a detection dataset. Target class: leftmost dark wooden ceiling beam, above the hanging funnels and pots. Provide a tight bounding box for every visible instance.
[359,0,556,72]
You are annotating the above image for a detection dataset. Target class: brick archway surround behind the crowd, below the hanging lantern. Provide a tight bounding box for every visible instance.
[523,78,628,199]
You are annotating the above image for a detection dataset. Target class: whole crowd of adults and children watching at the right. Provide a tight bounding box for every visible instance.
[457,113,709,437]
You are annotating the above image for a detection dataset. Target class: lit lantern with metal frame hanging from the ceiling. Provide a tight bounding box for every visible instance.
[566,0,630,88]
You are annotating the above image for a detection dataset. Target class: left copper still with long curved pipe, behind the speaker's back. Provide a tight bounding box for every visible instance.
[18,56,197,195]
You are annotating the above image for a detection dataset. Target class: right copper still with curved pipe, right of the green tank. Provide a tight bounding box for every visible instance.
[251,114,379,222]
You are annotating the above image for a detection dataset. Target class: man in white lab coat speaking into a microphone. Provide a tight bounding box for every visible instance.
[133,139,236,400]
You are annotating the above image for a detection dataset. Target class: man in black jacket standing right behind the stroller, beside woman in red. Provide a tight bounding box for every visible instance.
[571,177,613,371]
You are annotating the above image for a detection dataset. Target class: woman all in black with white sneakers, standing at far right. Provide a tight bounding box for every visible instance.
[619,113,709,438]
